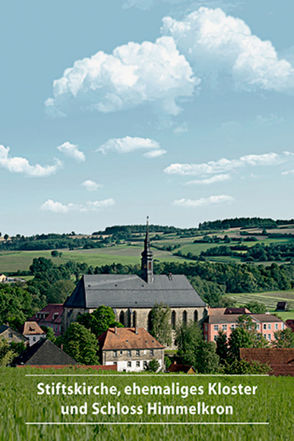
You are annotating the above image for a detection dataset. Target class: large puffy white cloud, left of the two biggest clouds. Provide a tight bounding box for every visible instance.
[45,36,200,115]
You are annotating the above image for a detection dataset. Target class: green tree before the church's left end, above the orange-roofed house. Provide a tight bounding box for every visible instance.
[77,305,123,337]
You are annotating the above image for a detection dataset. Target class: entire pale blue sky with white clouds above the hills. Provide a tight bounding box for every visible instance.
[0,0,294,234]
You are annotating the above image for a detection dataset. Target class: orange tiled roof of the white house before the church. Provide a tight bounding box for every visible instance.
[98,328,164,351]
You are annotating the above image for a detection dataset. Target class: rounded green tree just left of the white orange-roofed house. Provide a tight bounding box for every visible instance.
[63,323,99,365]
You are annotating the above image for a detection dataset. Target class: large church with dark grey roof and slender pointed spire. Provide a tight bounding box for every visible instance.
[63,221,206,330]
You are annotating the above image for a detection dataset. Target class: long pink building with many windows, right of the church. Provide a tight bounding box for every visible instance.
[203,314,285,342]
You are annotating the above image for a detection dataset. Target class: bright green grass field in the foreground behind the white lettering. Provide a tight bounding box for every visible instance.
[0,368,294,441]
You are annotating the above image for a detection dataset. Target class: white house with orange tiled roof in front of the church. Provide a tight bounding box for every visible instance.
[98,328,164,372]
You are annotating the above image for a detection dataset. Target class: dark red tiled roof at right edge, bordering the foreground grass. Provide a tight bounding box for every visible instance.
[240,348,294,376]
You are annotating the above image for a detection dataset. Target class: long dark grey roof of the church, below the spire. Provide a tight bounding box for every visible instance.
[64,274,205,309]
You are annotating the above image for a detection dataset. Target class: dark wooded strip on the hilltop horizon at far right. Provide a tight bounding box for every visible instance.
[199,217,294,230]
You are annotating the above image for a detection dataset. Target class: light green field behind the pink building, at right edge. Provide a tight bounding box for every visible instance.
[226,289,294,320]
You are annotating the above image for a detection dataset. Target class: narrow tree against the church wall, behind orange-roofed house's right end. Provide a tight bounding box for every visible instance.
[150,304,172,346]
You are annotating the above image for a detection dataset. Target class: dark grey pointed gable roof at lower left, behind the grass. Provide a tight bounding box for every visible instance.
[14,339,77,365]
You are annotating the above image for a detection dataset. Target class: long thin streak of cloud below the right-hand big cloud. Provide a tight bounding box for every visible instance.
[164,152,289,176]
